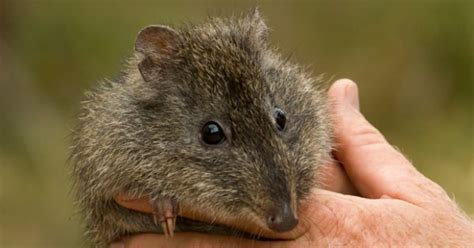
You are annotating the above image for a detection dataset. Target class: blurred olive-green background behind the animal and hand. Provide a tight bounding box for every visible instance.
[0,0,474,247]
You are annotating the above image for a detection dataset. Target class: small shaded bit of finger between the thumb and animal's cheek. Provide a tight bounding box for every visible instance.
[316,160,359,195]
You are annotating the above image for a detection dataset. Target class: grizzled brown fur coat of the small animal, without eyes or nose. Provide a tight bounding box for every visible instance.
[72,9,331,246]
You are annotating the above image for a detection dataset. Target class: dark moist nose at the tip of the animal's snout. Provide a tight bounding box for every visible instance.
[267,202,298,232]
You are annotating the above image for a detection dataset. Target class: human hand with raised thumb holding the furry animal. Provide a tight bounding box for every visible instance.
[113,80,474,247]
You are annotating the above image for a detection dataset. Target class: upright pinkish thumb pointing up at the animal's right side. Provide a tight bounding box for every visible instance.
[329,79,434,201]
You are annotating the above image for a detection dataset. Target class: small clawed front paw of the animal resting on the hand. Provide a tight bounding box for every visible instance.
[150,197,178,237]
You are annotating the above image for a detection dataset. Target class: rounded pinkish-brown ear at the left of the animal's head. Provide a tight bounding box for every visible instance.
[135,25,178,81]
